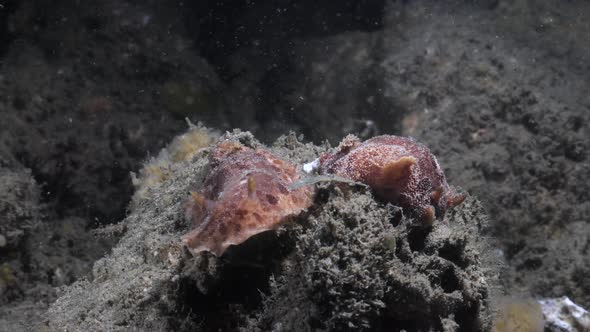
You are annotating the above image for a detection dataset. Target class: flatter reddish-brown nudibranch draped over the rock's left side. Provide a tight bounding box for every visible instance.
[182,141,313,256]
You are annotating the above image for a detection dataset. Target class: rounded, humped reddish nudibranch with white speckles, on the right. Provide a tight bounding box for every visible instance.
[319,135,465,224]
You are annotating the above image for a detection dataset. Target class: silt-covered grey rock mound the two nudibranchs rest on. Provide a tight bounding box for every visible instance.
[41,131,497,331]
